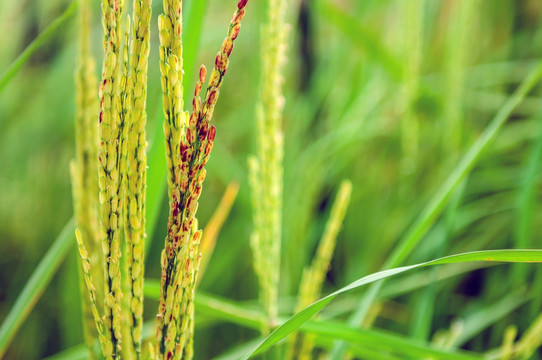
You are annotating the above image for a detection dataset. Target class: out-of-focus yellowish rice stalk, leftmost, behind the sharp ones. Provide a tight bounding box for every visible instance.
[70,0,103,358]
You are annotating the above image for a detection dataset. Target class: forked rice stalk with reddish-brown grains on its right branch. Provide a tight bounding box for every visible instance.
[155,0,251,359]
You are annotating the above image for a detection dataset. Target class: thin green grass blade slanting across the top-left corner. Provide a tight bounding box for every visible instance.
[0,1,77,93]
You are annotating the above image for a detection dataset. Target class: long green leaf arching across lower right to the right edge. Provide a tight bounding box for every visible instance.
[243,250,542,359]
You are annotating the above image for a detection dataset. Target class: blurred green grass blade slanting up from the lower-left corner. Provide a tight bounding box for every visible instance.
[0,219,75,358]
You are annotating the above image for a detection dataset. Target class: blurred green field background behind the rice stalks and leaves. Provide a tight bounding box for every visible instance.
[0,0,542,359]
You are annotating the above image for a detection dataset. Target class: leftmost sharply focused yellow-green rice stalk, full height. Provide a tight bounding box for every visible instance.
[98,0,123,358]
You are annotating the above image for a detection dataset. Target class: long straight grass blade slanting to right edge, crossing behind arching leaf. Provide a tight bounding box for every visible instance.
[332,62,542,360]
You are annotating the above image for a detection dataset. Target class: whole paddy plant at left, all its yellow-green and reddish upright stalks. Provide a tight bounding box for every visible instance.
[73,0,251,359]
